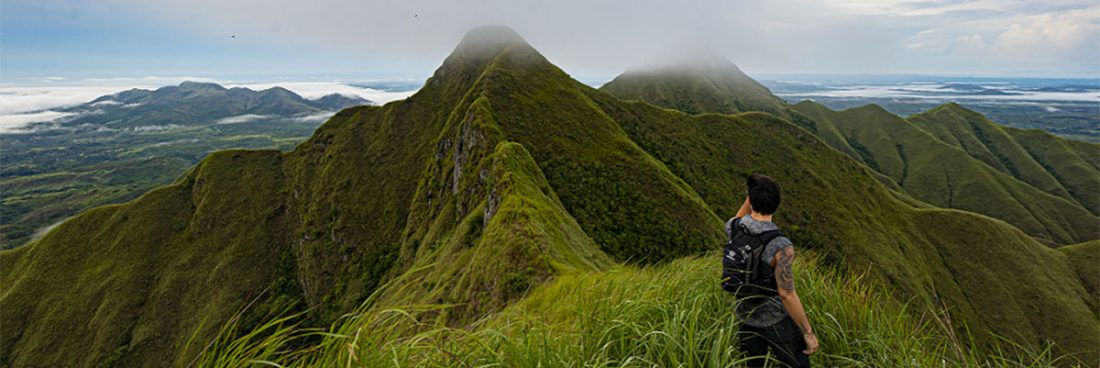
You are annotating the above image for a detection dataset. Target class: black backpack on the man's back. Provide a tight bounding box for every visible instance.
[722,219,782,299]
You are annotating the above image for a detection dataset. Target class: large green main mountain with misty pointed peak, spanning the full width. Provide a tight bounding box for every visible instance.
[0,27,1100,366]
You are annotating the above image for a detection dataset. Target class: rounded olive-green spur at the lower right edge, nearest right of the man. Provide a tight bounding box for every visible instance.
[914,210,1100,361]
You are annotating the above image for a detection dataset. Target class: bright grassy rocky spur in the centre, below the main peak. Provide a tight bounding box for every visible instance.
[381,142,612,322]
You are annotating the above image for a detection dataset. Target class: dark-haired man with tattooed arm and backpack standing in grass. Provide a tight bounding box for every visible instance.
[723,175,817,367]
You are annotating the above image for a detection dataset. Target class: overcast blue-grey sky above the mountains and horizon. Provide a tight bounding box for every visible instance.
[0,0,1100,82]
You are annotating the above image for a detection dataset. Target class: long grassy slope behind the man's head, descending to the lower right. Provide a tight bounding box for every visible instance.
[585,92,1100,360]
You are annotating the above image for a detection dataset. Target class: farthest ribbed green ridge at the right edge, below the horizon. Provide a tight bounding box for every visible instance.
[909,103,1100,214]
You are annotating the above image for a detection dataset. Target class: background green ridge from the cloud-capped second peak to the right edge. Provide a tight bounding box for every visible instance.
[601,56,1100,245]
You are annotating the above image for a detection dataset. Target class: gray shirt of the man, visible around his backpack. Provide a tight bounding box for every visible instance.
[726,214,794,327]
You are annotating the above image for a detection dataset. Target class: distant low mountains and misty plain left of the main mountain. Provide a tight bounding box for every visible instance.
[0,82,370,248]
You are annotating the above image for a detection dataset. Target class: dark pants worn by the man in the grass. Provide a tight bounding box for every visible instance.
[738,316,810,368]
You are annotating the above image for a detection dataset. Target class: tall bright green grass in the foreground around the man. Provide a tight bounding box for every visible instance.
[197,255,1071,367]
